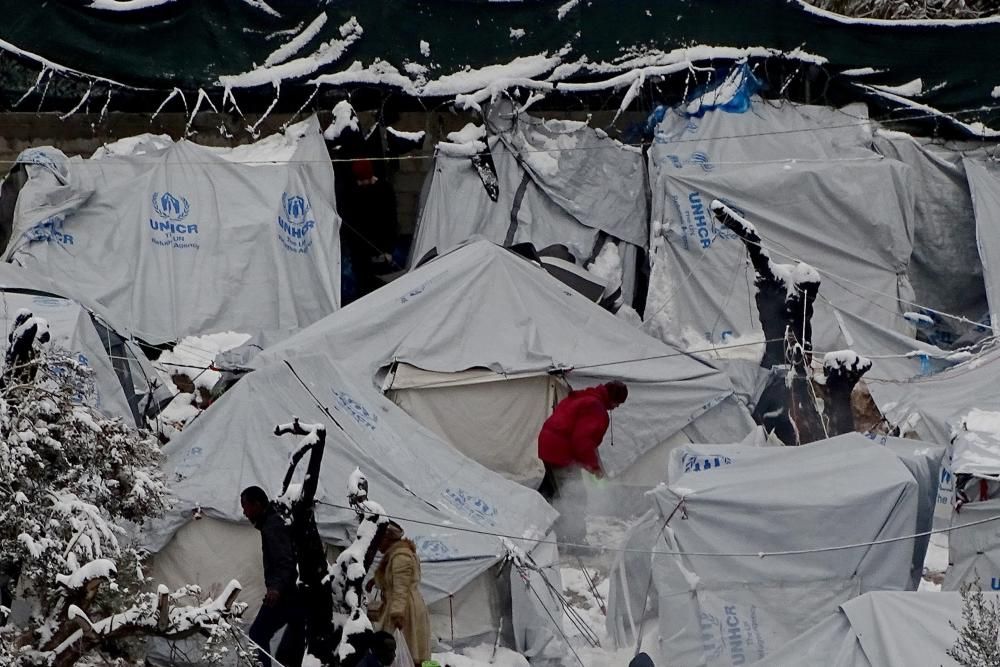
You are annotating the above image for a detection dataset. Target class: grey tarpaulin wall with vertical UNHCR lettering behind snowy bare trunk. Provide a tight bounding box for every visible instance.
[646,157,913,358]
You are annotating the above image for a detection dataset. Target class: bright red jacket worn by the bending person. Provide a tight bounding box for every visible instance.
[538,385,611,473]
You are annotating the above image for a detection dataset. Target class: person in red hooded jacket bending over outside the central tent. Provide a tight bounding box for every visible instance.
[538,380,628,543]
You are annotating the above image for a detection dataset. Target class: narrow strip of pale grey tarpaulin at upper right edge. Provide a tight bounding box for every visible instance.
[962,158,1000,331]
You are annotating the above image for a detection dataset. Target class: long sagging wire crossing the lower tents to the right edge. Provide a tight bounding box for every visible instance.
[316,498,1000,558]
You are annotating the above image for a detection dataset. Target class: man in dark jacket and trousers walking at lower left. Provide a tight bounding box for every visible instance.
[240,486,306,667]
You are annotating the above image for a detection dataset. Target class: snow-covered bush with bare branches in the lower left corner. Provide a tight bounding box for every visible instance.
[0,350,240,667]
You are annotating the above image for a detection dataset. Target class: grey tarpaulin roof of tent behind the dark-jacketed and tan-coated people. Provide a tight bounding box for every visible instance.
[147,351,555,602]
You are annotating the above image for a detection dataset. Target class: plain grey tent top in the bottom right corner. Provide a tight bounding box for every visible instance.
[753,591,993,667]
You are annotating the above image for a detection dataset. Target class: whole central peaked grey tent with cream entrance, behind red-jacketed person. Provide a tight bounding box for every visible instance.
[254,241,753,486]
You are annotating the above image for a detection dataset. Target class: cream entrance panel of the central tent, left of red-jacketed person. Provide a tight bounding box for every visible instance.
[384,363,568,485]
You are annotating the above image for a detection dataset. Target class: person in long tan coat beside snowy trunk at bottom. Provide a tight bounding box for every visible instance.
[368,522,431,667]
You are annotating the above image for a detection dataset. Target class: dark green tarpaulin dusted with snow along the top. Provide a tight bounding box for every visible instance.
[0,0,1000,129]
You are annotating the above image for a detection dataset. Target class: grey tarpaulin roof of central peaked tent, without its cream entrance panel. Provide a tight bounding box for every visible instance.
[254,241,753,476]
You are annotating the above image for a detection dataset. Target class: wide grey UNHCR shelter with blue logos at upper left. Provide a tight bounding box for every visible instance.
[4,118,340,344]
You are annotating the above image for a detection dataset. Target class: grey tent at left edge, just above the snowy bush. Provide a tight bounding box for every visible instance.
[0,264,170,428]
